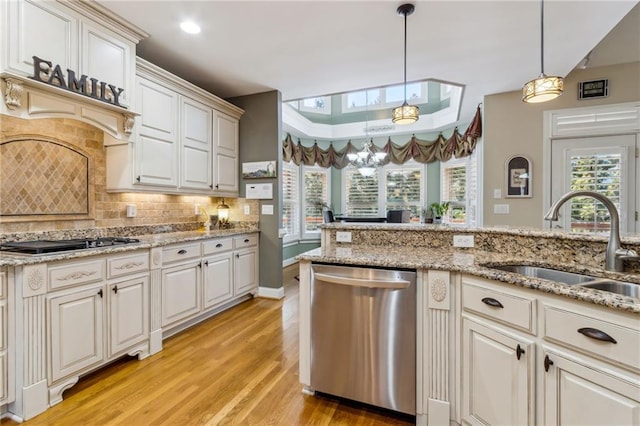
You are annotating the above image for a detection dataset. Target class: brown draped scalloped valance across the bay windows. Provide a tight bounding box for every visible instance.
[282,106,482,169]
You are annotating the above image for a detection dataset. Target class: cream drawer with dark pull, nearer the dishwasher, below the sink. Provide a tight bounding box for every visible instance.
[462,280,536,333]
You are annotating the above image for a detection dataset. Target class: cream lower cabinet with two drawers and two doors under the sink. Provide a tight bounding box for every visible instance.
[460,275,640,426]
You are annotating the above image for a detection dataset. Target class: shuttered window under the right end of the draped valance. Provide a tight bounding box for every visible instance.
[440,152,477,226]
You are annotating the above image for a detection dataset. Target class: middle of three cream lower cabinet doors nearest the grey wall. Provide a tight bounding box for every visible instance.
[203,252,233,308]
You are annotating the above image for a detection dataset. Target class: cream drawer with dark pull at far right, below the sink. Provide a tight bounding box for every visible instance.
[543,306,640,369]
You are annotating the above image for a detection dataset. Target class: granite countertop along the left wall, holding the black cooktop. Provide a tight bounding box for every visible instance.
[0,228,260,266]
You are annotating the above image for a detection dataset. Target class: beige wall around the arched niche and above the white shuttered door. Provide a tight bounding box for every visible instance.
[483,62,640,227]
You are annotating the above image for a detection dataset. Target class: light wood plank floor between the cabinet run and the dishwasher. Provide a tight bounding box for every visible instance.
[2,265,413,426]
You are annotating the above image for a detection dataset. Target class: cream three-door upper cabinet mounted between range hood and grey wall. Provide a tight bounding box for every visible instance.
[105,58,244,197]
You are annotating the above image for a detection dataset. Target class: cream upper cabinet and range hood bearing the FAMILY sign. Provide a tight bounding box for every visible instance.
[0,0,147,139]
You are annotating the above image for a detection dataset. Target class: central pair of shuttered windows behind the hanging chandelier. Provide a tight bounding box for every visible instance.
[342,161,426,222]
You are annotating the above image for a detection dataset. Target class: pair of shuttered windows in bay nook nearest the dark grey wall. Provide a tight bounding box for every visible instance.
[282,163,331,243]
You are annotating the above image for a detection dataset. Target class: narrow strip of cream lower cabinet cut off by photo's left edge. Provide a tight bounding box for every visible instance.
[0,268,15,413]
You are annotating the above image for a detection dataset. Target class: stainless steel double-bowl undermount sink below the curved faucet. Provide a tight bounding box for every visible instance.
[490,265,640,299]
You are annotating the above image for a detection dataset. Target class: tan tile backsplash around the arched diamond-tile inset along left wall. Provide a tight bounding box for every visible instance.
[0,114,259,234]
